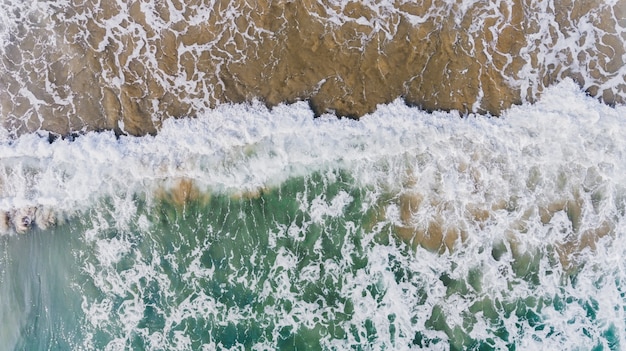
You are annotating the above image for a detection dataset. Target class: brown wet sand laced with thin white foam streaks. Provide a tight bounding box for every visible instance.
[0,0,626,135]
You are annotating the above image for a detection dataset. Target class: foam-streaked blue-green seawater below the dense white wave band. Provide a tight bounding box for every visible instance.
[0,169,626,350]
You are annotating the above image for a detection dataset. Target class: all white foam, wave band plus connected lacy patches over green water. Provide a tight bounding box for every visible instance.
[0,81,626,350]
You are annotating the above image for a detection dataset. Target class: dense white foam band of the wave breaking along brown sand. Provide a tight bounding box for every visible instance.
[0,77,626,234]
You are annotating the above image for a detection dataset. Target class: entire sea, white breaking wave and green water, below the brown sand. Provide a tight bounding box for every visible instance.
[0,81,626,350]
